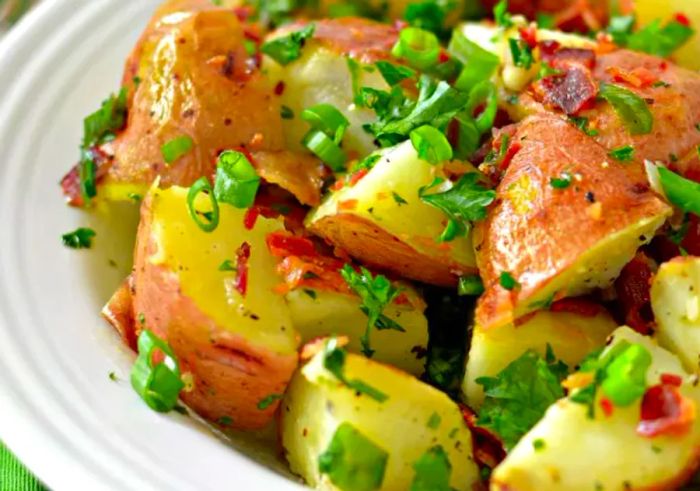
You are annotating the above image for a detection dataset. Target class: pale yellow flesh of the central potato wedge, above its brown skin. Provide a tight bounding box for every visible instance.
[307,141,476,282]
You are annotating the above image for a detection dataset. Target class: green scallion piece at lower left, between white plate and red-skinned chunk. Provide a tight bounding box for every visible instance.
[131,329,185,412]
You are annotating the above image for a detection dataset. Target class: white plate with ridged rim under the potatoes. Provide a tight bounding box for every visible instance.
[0,0,299,491]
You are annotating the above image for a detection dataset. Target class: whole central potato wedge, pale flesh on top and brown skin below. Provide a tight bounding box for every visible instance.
[307,141,476,286]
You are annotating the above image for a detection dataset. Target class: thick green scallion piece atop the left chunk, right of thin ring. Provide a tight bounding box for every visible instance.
[213,150,260,209]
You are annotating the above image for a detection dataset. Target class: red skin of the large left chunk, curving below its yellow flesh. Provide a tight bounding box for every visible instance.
[133,194,298,430]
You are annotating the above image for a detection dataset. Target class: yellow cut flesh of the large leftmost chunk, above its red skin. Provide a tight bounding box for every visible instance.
[150,187,298,353]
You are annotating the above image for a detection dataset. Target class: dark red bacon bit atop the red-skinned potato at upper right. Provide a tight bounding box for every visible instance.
[534,63,598,115]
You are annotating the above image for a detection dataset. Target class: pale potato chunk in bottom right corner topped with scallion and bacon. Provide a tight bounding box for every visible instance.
[491,327,700,491]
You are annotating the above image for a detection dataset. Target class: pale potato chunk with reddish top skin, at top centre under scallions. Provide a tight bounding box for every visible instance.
[263,18,398,158]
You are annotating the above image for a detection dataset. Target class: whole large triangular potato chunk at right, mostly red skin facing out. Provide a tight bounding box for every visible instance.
[474,115,671,329]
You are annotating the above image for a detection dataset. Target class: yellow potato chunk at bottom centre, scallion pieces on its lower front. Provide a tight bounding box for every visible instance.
[281,353,479,491]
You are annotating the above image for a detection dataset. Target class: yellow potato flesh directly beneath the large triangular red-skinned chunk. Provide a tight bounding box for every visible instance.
[462,311,617,410]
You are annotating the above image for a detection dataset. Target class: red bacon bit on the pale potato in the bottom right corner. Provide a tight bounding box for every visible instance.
[637,385,695,438]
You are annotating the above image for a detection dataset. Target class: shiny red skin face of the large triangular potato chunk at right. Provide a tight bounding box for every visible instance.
[474,115,668,329]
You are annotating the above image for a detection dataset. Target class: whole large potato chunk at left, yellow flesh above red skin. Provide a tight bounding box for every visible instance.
[133,186,299,429]
